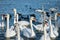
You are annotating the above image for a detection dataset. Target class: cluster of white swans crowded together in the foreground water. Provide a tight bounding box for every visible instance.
[0,9,59,40]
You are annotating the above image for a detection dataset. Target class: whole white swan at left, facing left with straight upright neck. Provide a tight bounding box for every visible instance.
[5,14,16,38]
